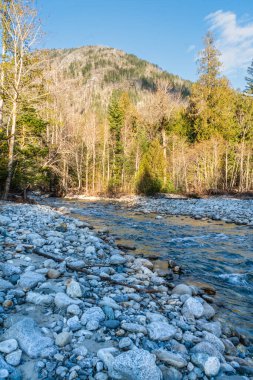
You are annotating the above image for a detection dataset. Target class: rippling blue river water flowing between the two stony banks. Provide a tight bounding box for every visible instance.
[42,199,253,336]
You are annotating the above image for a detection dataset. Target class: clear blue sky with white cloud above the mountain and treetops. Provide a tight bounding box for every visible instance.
[36,0,253,89]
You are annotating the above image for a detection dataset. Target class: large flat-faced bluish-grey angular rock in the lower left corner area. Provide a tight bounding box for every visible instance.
[4,317,53,358]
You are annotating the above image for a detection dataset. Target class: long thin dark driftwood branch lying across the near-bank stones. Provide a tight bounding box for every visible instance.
[33,249,161,294]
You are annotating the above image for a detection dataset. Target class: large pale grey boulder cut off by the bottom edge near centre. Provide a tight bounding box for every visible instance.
[109,349,162,380]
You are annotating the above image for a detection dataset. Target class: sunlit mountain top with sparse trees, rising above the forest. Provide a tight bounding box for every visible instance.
[47,46,191,113]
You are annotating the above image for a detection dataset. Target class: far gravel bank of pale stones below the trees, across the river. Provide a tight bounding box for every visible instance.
[66,195,253,226]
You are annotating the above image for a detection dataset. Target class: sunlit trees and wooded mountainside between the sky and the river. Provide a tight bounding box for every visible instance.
[0,0,253,199]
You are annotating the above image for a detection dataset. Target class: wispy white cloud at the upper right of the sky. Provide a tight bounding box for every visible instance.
[206,10,253,76]
